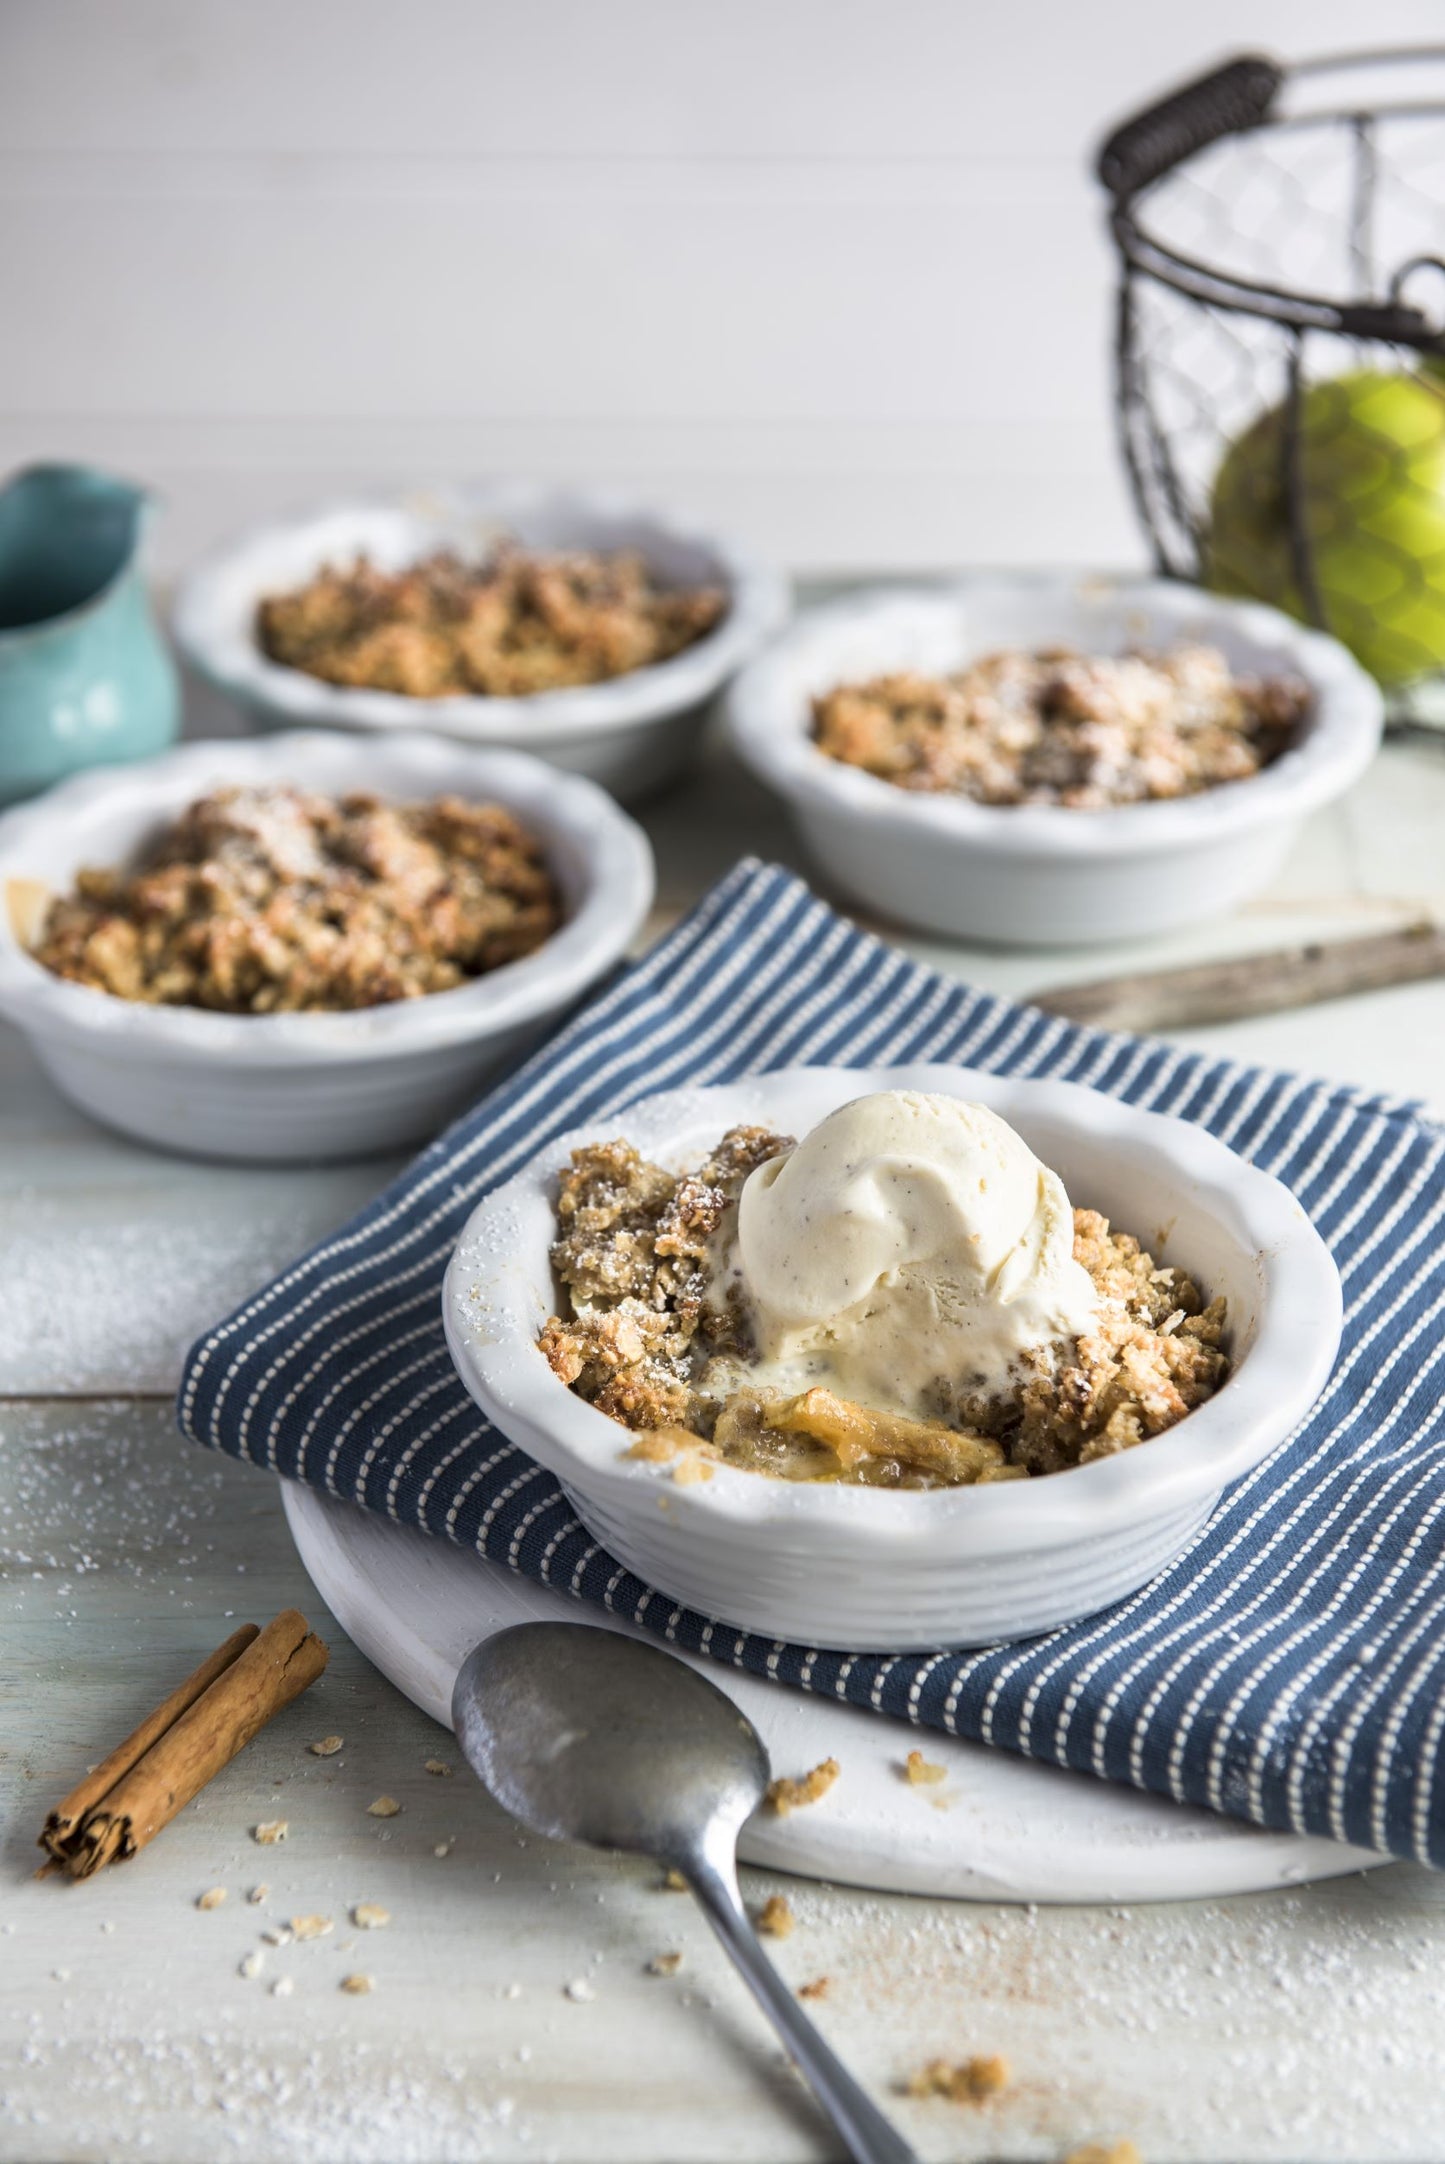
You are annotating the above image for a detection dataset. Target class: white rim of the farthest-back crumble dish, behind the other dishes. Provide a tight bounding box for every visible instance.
[171,480,787,751]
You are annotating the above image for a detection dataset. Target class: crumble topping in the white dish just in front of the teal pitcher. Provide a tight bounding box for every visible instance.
[32,788,562,1015]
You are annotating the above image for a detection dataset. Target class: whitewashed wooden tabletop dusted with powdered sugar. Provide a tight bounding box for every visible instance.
[0,631,1445,2164]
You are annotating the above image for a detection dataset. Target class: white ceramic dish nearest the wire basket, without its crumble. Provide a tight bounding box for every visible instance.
[727,578,1382,946]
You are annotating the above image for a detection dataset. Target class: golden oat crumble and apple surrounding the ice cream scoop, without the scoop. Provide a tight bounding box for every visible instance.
[539,1127,1229,1487]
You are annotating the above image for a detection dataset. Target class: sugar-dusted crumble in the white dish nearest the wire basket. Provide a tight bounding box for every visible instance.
[813,645,1309,812]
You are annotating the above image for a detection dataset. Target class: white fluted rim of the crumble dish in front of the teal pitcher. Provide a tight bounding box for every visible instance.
[0,729,653,1069]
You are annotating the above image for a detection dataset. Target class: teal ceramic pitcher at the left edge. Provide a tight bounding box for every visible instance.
[0,465,180,803]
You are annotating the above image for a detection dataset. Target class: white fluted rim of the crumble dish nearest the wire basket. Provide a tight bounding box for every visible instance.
[727,573,1382,859]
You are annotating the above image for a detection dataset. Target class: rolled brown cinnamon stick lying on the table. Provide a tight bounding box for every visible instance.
[41,1608,329,1878]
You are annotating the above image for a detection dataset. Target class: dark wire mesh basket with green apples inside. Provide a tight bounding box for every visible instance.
[1099,48,1445,727]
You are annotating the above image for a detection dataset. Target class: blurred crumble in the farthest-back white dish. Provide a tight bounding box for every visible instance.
[255,543,727,699]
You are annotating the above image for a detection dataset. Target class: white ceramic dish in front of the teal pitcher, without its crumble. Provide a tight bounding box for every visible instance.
[0,731,653,1162]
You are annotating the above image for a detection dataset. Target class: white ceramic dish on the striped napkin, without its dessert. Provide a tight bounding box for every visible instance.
[443,1067,1341,1653]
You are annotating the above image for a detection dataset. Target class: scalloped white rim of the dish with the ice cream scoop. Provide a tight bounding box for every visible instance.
[441,1065,1343,1560]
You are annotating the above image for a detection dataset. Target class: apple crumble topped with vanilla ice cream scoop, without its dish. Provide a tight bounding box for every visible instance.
[539,1093,1229,1489]
